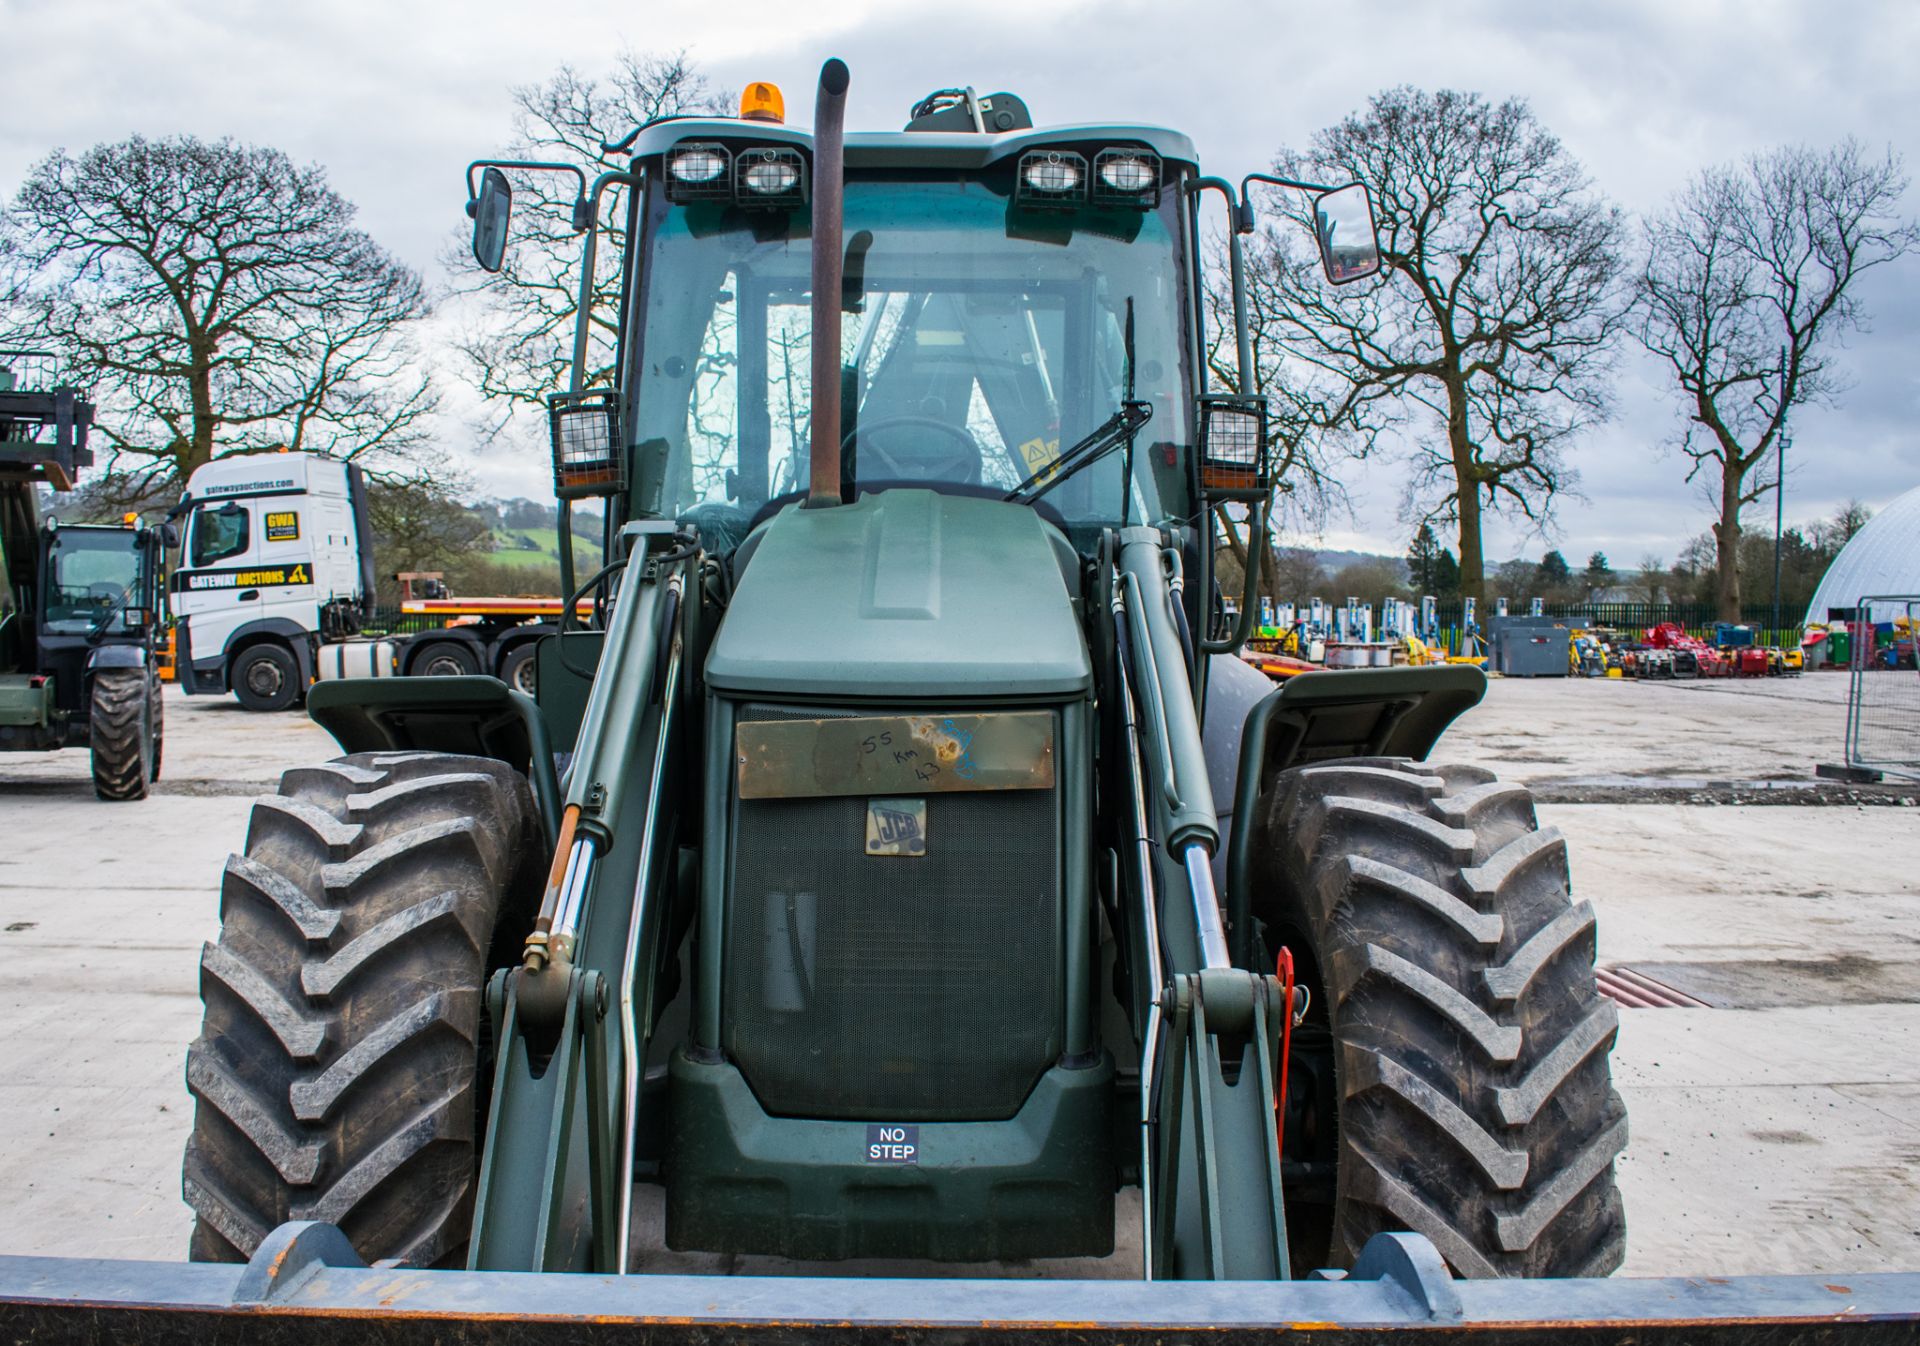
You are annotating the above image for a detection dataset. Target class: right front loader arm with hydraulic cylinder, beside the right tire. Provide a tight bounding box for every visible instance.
[1108,528,1290,1281]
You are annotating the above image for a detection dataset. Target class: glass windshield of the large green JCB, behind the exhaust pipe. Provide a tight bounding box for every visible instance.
[632,173,1188,549]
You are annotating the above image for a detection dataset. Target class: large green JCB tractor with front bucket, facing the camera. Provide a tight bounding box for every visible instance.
[0,61,1920,1342]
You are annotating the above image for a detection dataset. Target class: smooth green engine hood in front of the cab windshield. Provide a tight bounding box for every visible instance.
[707,490,1092,699]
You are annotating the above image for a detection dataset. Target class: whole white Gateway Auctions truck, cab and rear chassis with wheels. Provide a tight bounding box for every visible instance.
[171,453,561,710]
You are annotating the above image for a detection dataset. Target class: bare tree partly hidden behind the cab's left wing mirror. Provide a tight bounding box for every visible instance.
[445,52,722,428]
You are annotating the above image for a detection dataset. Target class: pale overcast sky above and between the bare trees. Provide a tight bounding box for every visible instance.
[0,0,1920,566]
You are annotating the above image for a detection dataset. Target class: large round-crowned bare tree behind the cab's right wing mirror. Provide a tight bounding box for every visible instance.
[1248,86,1622,597]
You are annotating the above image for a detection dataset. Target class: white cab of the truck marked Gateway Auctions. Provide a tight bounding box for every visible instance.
[173,453,374,710]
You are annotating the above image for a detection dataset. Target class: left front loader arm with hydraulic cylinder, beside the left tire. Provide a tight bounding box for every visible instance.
[468,524,695,1271]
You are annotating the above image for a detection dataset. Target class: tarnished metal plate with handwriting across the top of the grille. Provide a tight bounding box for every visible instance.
[733,710,1054,799]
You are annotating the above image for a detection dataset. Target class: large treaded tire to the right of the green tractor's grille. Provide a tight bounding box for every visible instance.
[1256,758,1626,1277]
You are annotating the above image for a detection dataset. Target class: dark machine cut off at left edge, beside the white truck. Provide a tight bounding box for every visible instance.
[0,351,169,799]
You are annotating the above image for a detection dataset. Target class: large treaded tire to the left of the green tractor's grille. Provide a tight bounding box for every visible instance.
[182,753,545,1265]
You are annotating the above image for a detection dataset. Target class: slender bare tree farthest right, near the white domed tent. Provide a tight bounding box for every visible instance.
[1638,140,1920,622]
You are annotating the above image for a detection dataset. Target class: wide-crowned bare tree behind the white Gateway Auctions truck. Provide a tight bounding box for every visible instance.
[0,136,434,495]
